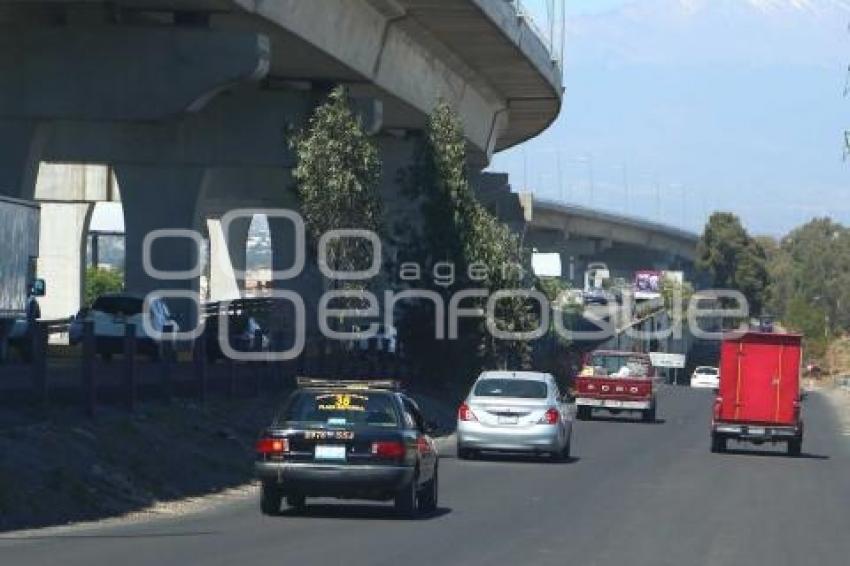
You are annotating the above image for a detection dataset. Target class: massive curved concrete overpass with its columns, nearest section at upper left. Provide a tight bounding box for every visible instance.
[0,0,562,324]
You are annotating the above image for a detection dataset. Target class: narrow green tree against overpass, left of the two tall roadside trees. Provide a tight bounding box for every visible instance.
[289,87,382,287]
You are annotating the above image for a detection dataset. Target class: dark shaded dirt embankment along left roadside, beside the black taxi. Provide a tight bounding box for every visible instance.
[0,393,454,531]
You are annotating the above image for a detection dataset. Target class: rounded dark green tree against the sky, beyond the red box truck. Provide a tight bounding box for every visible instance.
[696,212,768,314]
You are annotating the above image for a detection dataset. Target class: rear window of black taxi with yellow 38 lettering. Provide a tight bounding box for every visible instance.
[277,390,400,428]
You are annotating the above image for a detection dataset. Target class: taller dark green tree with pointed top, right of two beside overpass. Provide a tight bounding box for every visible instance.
[399,103,538,375]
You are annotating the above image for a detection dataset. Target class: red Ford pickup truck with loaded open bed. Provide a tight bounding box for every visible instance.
[575,350,655,422]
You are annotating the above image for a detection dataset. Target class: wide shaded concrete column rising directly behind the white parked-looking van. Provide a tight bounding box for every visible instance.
[115,165,206,331]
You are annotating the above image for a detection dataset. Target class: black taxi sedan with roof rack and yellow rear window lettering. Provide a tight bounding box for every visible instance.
[255,378,439,518]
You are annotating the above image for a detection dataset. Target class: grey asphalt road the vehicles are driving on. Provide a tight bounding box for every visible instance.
[0,388,850,566]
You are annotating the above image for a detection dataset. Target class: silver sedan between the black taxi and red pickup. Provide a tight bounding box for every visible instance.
[457,371,572,460]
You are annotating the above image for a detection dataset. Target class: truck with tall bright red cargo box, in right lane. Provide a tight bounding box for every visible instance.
[711,332,803,456]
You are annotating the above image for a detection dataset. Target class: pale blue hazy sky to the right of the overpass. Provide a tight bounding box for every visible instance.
[491,0,850,235]
